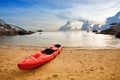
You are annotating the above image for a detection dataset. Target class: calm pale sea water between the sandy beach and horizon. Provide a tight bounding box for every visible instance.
[0,31,120,48]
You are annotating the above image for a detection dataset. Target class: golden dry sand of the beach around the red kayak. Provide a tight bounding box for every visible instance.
[0,47,120,80]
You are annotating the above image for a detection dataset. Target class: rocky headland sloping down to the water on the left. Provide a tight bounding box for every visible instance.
[0,19,34,36]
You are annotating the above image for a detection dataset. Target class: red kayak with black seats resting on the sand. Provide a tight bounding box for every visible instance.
[18,44,62,70]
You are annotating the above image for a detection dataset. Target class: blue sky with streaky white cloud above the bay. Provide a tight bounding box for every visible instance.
[0,0,120,30]
